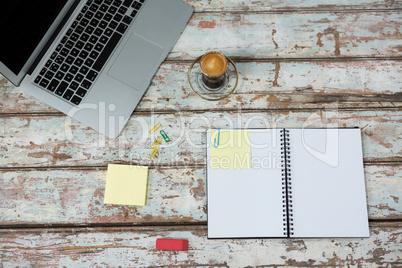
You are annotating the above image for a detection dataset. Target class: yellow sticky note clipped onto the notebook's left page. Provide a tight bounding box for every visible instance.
[210,130,251,169]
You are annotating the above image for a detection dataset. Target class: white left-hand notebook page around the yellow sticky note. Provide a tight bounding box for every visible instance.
[207,129,284,238]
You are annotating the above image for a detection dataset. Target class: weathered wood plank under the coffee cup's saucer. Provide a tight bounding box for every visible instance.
[0,61,402,113]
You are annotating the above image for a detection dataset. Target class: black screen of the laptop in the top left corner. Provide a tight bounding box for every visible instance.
[0,0,67,74]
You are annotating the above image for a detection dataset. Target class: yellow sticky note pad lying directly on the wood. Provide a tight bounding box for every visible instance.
[104,164,148,206]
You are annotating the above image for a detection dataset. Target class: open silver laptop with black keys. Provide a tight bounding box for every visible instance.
[0,0,193,138]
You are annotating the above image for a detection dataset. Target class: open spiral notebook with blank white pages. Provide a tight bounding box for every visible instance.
[207,128,369,238]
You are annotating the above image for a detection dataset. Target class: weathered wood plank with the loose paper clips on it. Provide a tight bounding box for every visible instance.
[0,109,402,167]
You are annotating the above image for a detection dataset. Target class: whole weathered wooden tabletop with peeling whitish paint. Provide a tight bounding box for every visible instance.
[0,0,402,267]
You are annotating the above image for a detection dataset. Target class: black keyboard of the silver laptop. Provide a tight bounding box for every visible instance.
[34,0,145,105]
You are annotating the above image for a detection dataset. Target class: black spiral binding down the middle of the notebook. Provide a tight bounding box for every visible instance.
[280,129,294,237]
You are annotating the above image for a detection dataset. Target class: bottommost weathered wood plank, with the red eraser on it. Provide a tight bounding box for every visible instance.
[0,223,402,267]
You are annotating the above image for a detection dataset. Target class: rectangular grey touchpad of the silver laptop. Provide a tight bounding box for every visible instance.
[108,34,163,90]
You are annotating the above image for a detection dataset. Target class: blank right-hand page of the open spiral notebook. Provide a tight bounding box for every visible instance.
[289,129,369,237]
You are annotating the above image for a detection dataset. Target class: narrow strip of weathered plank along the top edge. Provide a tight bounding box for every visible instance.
[184,0,401,12]
